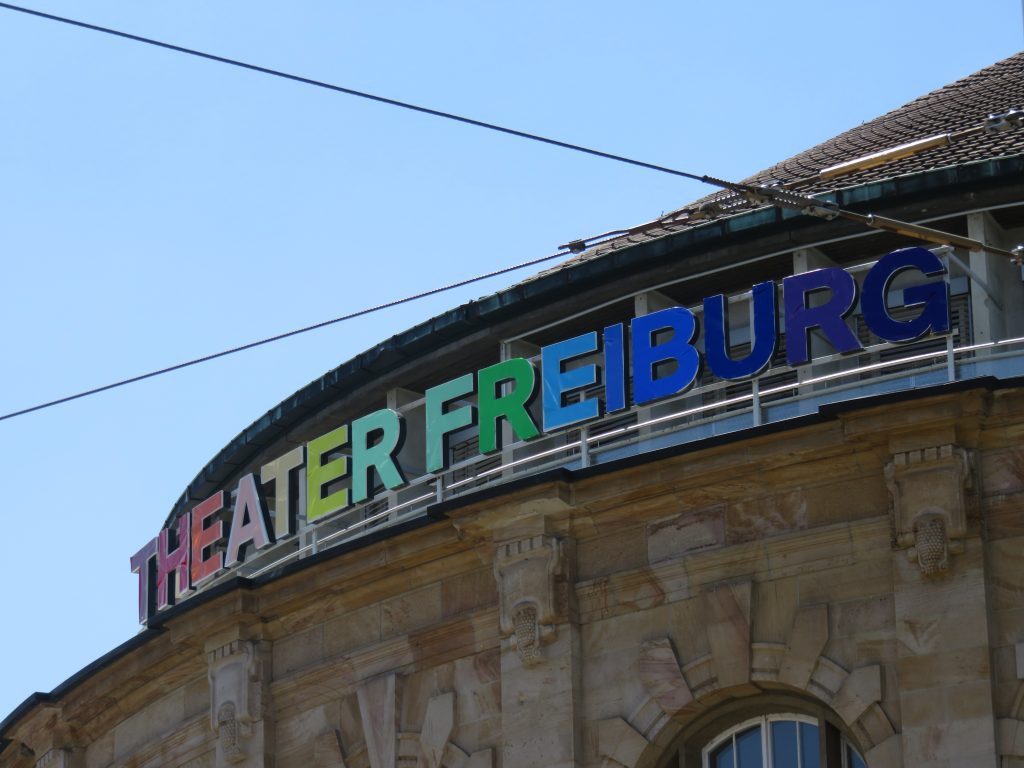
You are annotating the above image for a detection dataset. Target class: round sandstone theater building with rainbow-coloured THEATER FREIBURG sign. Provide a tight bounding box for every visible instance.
[6,54,1024,768]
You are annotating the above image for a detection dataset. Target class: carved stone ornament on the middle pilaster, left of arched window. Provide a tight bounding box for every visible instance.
[495,535,566,666]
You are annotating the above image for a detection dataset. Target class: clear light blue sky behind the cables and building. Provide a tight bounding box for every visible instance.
[0,0,1024,718]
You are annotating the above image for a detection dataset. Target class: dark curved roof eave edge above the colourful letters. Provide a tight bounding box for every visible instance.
[165,155,1024,525]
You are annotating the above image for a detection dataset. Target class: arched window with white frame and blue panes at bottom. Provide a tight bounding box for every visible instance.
[703,714,866,768]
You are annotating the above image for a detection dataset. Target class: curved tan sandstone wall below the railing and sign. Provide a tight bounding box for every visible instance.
[6,387,1024,768]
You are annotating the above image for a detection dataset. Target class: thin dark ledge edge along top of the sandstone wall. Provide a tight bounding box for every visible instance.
[6,376,1024,753]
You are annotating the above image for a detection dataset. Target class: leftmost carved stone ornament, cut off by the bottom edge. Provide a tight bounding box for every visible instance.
[207,640,263,765]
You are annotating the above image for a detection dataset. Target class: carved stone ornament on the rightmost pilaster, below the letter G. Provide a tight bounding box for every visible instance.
[886,444,974,575]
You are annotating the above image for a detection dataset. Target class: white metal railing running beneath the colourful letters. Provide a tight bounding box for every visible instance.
[195,243,1024,583]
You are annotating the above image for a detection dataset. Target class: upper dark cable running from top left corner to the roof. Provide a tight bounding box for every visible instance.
[0,2,721,186]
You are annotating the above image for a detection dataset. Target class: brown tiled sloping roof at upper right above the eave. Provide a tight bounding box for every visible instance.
[541,51,1024,274]
